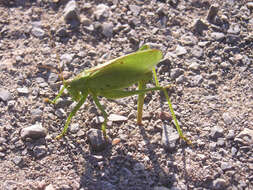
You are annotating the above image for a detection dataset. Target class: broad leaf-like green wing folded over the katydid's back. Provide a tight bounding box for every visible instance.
[86,49,162,92]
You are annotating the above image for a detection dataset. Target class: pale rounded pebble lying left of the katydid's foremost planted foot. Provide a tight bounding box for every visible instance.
[20,123,47,139]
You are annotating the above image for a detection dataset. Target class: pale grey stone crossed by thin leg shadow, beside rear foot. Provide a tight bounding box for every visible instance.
[162,125,179,151]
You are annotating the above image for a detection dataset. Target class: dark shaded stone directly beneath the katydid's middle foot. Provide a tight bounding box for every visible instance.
[87,129,107,152]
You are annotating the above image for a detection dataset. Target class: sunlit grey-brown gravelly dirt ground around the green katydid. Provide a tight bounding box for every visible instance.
[0,0,253,190]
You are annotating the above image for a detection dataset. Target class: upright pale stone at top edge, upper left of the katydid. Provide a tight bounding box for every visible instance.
[63,0,80,22]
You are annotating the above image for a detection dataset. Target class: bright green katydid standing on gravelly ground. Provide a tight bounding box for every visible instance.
[48,45,190,143]
